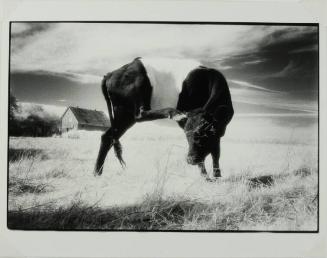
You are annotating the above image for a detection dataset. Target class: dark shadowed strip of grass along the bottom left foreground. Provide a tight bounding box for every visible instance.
[7,200,206,231]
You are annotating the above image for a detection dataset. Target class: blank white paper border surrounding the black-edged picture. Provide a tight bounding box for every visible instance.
[0,0,327,257]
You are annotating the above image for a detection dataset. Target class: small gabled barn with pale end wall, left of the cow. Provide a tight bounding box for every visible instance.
[60,107,110,133]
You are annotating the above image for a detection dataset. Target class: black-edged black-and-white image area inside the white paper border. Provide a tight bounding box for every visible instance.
[7,22,319,232]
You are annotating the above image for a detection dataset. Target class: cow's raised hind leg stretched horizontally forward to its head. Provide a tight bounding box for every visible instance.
[135,108,185,122]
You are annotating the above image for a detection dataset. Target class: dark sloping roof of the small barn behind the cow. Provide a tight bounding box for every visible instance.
[63,107,110,127]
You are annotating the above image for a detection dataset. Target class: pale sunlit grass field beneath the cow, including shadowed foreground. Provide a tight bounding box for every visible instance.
[8,118,318,231]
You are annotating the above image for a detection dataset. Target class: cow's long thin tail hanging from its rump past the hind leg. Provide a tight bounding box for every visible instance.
[101,75,126,167]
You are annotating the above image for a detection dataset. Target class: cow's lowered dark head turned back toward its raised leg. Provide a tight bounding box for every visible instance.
[176,109,217,165]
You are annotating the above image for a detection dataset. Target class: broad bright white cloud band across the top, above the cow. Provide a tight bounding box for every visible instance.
[12,23,304,81]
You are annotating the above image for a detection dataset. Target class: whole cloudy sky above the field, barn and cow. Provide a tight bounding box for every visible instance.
[10,23,318,116]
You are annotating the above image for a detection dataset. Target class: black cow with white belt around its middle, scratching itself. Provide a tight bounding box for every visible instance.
[94,58,234,179]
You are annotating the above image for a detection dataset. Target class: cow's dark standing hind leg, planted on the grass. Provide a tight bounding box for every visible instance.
[94,108,135,176]
